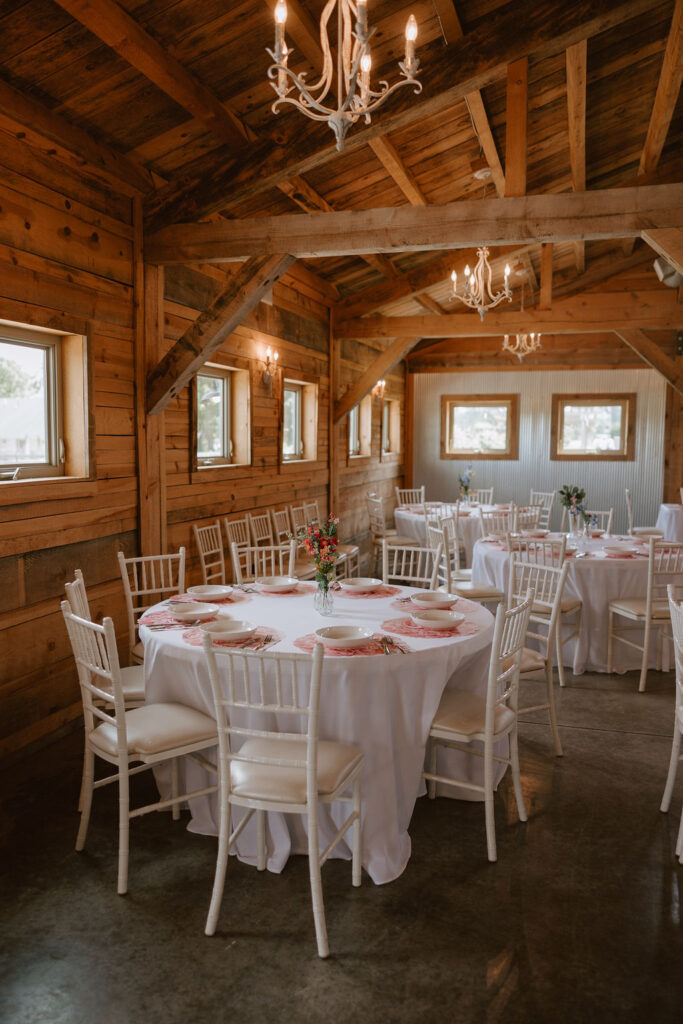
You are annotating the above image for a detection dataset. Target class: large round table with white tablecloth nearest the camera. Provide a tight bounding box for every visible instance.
[140,584,493,883]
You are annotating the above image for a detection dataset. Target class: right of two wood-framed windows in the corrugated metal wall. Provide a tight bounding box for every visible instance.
[550,393,636,462]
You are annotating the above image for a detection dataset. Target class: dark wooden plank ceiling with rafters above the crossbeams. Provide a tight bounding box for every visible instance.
[0,0,683,380]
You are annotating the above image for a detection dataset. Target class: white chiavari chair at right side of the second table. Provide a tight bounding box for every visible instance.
[607,537,683,693]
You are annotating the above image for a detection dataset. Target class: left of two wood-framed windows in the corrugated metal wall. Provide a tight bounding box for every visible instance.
[441,394,519,459]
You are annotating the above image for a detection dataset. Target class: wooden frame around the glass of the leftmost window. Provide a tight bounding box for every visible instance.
[0,319,96,483]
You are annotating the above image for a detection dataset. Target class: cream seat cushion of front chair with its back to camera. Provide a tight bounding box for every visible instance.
[230,739,362,804]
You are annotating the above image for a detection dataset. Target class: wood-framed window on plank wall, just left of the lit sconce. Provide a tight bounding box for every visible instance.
[194,362,250,470]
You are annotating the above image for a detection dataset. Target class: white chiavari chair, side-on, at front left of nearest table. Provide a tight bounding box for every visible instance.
[61,601,218,894]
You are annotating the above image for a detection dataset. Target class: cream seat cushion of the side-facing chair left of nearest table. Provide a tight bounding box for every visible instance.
[90,703,218,757]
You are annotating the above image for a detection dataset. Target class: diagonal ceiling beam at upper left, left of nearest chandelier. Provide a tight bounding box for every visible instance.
[56,0,247,148]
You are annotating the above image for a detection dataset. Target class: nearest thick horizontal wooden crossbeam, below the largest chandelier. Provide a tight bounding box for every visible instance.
[145,184,683,263]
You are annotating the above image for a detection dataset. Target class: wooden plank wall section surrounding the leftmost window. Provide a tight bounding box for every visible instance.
[0,133,137,756]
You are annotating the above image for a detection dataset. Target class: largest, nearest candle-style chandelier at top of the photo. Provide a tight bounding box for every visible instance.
[266,0,422,151]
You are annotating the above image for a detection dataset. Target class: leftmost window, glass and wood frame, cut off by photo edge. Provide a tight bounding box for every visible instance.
[0,323,90,480]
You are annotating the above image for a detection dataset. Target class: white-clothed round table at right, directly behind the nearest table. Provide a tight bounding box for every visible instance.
[472,534,668,676]
